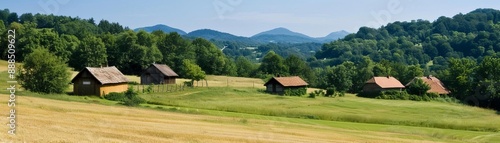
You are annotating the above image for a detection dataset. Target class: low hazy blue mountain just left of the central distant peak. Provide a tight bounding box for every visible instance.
[184,29,258,45]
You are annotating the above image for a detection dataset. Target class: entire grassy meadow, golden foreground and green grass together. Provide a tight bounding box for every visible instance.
[0,61,500,143]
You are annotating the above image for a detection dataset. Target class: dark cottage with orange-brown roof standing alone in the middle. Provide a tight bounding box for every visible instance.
[264,76,309,94]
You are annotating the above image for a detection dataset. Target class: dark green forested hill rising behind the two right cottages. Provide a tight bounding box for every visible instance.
[315,9,500,68]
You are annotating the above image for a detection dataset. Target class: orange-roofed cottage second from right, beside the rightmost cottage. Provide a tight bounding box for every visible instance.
[363,76,405,92]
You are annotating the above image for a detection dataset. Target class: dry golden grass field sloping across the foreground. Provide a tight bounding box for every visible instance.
[0,95,454,143]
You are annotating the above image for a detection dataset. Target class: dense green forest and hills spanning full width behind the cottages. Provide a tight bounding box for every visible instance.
[0,9,500,108]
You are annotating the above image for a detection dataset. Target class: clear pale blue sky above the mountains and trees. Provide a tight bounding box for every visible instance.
[0,0,500,37]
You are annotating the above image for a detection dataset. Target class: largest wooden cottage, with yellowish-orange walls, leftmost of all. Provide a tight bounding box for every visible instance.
[71,66,128,96]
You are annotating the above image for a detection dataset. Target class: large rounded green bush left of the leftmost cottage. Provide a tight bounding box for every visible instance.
[17,49,71,93]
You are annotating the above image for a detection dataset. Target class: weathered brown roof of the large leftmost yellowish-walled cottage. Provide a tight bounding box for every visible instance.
[71,66,128,84]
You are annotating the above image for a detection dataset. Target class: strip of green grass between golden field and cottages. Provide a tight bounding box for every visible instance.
[141,88,500,132]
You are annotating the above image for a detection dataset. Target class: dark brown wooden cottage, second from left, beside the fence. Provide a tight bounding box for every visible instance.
[141,64,179,84]
